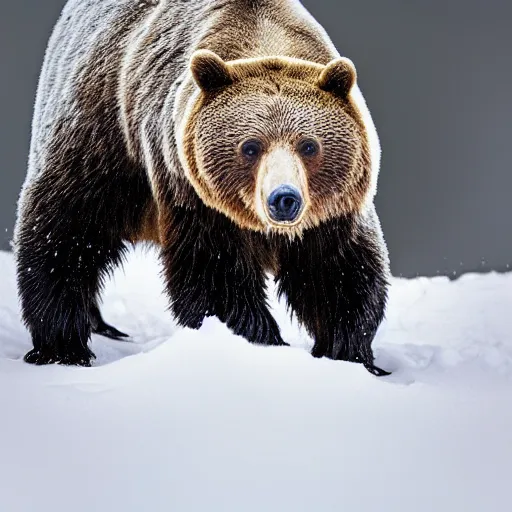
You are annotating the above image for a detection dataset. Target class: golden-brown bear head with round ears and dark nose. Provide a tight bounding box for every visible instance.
[178,50,372,235]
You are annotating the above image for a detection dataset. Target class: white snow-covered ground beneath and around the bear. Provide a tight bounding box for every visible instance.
[0,246,512,512]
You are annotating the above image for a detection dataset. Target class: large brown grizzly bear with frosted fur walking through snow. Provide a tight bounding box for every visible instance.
[14,0,390,376]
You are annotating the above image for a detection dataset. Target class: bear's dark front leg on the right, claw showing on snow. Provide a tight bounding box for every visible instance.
[276,213,388,376]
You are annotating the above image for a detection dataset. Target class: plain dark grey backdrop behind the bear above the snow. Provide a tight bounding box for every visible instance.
[0,0,512,276]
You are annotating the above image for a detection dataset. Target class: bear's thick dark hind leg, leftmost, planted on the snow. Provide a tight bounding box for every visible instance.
[17,194,129,366]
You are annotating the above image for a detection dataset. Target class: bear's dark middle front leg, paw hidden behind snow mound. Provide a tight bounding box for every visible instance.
[162,206,286,345]
